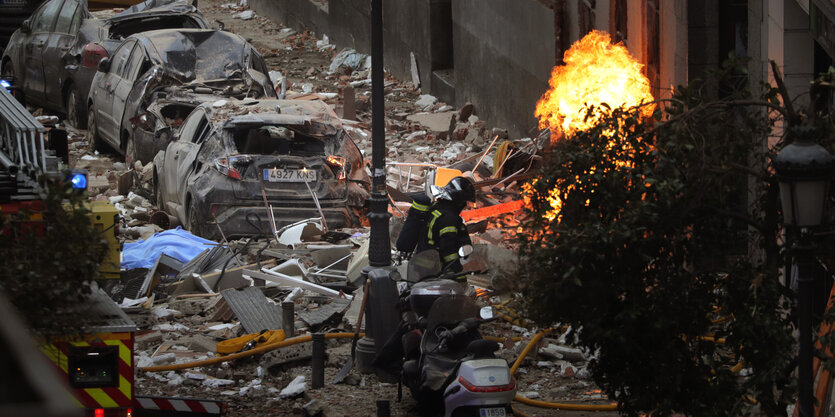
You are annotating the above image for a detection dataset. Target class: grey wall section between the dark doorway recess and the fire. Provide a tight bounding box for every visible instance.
[452,0,562,137]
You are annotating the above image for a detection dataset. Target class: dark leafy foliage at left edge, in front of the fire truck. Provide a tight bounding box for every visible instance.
[0,179,107,336]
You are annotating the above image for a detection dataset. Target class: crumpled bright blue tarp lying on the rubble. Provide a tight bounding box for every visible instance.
[122,226,217,269]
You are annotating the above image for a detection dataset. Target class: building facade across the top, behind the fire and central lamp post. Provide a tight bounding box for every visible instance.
[250,0,835,137]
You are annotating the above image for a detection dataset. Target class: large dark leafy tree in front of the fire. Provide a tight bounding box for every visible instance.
[520,60,794,416]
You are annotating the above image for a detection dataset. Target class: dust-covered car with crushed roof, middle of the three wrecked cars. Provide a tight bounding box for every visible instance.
[87,29,275,163]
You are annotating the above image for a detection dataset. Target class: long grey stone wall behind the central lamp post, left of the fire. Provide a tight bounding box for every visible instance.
[249,0,565,137]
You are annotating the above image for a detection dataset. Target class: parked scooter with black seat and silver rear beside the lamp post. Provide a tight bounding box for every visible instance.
[390,247,516,417]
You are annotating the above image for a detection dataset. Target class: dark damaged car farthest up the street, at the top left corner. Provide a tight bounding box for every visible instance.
[0,0,210,128]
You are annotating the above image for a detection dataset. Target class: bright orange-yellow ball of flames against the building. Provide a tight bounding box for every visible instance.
[535,30,654,140]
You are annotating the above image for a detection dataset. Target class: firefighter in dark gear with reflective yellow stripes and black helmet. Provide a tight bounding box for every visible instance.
[416,177,475,279]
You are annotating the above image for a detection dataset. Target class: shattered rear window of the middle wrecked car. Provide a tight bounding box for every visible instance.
[152,30,245,83]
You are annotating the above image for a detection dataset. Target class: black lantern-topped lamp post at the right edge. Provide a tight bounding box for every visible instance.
[774,126,833,417]
